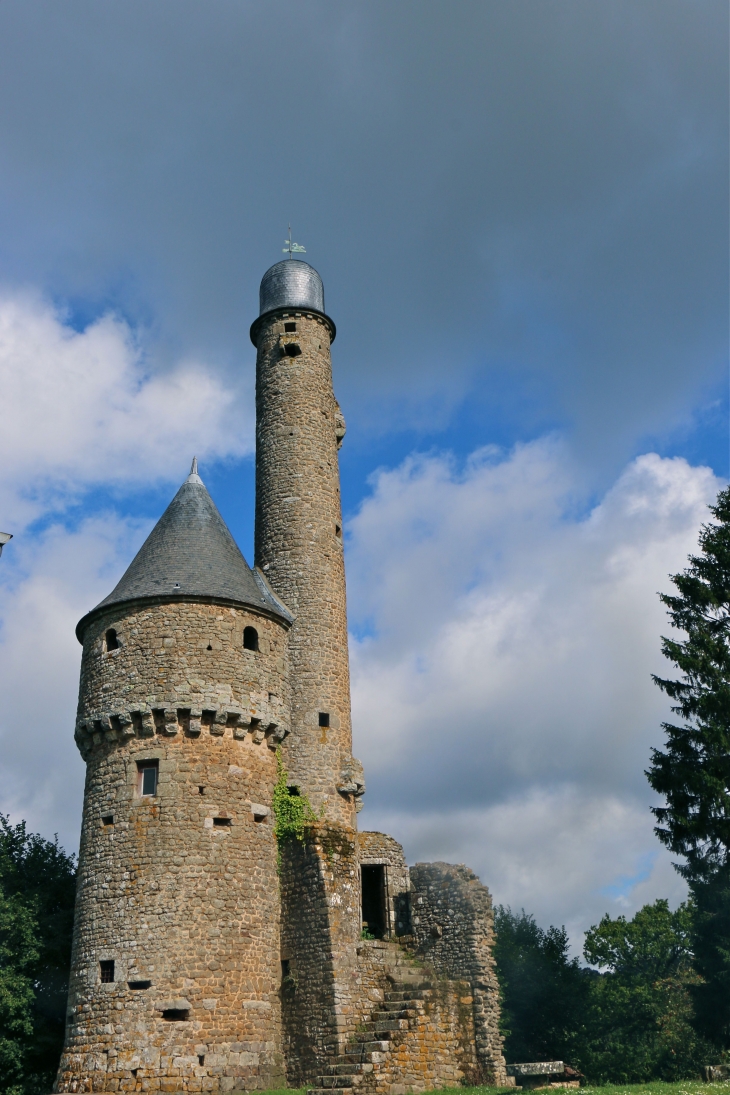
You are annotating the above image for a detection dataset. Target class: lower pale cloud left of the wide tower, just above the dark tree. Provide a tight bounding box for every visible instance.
[0,516,147,850]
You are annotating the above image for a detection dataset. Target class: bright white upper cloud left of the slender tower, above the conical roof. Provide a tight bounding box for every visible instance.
[0,292,253,528]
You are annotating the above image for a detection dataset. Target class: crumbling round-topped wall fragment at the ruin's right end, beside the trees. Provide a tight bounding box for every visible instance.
[410,863,507,1084]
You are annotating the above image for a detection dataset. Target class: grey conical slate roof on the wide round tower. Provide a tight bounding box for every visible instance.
[77,460,292,642]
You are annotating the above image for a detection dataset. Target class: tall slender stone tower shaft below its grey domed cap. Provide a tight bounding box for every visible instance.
[255,310,363,828]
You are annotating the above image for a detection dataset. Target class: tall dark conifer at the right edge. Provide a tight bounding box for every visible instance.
[647,488,730,1049]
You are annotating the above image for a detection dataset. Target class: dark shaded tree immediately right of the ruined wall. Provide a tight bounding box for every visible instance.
[494,906,589,1064]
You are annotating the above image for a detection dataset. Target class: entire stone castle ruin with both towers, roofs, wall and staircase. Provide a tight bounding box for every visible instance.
[56,263,505,1095]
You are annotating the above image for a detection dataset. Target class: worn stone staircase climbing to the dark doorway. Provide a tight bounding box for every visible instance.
[308,963,446,1095]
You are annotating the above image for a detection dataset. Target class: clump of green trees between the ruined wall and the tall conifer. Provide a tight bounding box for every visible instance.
[495,901,708,1083]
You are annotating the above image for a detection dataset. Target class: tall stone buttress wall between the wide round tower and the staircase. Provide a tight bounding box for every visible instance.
[281,825,360,1086]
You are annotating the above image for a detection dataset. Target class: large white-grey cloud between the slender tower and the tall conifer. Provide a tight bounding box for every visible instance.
[348,439,720,933]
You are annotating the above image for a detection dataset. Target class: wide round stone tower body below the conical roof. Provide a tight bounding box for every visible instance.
[57,602,289,1092]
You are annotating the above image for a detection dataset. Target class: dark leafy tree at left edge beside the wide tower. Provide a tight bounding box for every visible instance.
[0,815,76,1095]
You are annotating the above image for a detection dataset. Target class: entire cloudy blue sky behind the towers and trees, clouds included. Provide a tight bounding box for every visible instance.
[0,0,730,940]
